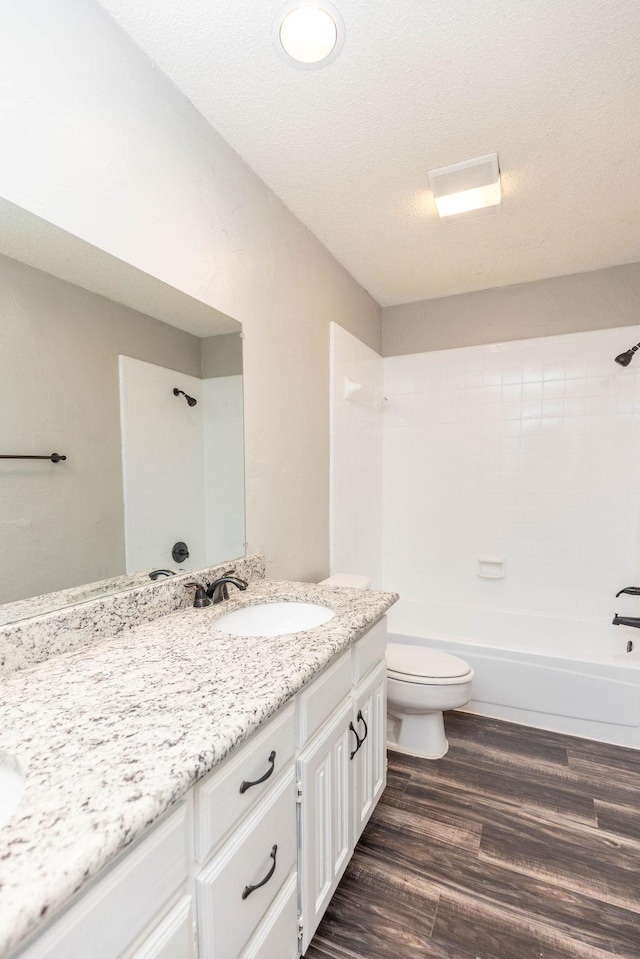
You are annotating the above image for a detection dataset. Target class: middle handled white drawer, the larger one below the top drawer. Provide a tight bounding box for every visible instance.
[196,767,297,959]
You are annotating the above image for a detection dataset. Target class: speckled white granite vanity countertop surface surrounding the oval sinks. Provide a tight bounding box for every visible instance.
[0,580,398,957]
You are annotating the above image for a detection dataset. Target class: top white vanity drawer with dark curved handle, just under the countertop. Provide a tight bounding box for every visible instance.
[195,703,295,863]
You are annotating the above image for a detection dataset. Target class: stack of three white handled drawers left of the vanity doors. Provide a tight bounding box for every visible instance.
[195,703,298,959]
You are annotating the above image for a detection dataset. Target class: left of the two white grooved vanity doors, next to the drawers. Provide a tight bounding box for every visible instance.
[298,698,355,953]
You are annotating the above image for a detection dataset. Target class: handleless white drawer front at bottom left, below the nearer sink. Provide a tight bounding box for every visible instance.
[21,804,187,959]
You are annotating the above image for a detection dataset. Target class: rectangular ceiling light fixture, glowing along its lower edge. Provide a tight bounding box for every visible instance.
[428,153,502,219]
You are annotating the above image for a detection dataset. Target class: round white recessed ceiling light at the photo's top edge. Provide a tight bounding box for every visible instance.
[271,0,345,70]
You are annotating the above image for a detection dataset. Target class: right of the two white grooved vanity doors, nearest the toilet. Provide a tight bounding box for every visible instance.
[352,660,387,845]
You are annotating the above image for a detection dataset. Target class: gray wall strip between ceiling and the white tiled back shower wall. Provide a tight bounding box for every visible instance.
[382,263,640,356]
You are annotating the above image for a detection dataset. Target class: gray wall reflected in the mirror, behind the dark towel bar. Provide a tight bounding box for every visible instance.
[0,257,201,603]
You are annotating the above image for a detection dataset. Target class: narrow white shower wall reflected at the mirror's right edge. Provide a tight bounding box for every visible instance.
[202,376,245,563]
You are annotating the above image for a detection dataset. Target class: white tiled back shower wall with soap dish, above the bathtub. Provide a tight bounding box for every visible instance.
[382,326,640,620]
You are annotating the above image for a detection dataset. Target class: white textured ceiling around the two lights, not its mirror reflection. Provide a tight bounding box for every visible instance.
[95,0,640,305]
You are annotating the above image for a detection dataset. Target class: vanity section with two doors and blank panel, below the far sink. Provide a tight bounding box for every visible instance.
[297,620,387,954]
